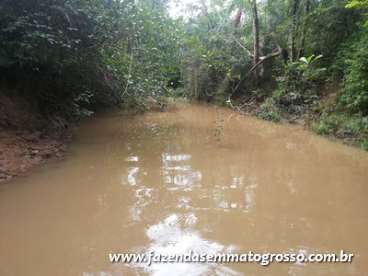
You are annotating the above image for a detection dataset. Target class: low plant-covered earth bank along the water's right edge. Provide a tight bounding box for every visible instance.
[230,93,368,150]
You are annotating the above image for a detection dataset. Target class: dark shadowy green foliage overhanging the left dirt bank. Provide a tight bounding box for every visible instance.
[0,0,132,116]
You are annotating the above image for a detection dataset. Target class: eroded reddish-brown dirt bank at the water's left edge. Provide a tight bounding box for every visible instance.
[0,96,71,184]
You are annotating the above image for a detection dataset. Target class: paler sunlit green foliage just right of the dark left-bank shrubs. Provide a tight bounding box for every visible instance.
[104,2,181,109]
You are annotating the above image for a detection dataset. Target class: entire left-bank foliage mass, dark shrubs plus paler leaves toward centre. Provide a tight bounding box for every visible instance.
[0,0,181,116]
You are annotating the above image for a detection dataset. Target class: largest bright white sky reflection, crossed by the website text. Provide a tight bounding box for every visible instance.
[131,213,241,276]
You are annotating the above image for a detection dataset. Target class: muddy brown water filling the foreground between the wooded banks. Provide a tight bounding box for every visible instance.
[0,105,368,276]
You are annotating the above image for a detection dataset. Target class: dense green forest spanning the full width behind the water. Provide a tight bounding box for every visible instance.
[0,0,368,148]
